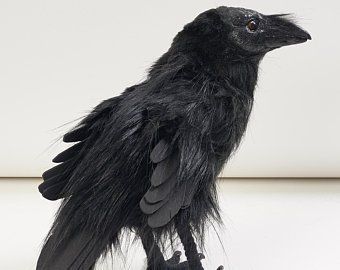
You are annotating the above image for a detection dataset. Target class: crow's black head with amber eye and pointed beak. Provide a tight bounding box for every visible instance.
[175,6,311,61]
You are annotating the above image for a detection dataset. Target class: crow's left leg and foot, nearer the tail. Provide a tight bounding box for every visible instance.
[140,228,181,270]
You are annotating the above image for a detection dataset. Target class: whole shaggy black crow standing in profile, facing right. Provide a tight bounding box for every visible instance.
[37,4,311,270]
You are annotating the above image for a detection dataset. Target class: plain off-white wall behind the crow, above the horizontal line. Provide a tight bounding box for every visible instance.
[0,0,340,177]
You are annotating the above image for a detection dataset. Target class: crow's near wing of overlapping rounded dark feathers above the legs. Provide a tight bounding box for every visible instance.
[140,123,217,228]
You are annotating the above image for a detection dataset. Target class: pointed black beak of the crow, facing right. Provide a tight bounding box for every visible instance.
[265,15,312,49]
